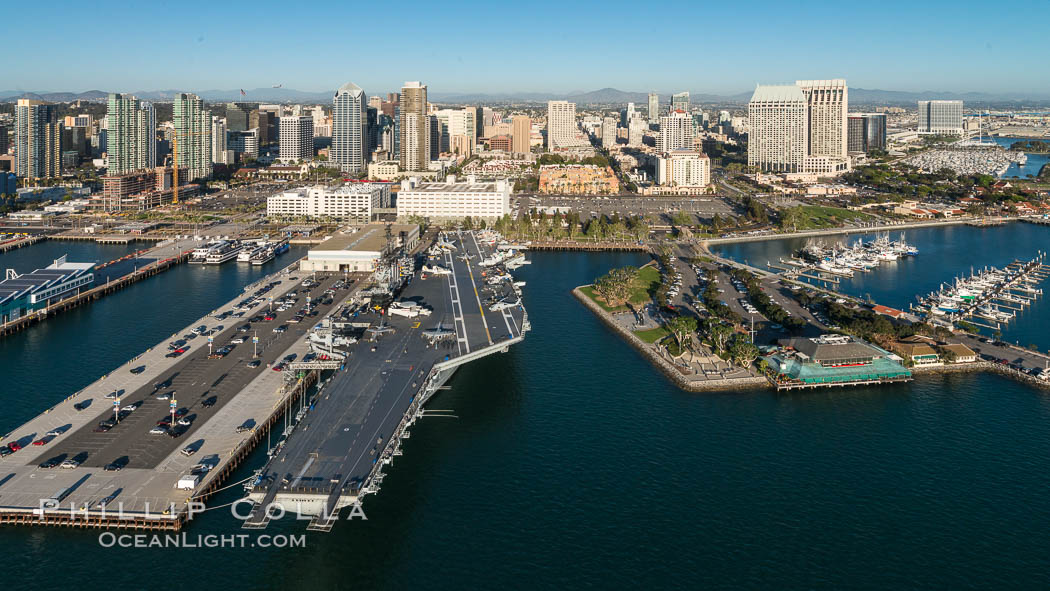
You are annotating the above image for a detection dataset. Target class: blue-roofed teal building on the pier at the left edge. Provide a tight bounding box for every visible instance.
[0,256,95,322]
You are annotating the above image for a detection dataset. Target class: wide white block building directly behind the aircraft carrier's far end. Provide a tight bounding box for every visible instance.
[397,175,510,219]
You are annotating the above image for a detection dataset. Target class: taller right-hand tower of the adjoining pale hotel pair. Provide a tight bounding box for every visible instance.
[795,80,849,160]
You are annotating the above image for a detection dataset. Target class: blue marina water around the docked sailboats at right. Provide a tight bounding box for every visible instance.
[713,221,1050,351]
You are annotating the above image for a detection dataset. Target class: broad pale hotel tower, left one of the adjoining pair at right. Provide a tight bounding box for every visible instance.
[743,84,810,172]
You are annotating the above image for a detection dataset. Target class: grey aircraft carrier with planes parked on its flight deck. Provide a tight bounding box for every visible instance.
[244,232,529,531]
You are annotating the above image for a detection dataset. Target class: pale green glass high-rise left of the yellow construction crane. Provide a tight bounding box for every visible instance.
[106,92,156,175]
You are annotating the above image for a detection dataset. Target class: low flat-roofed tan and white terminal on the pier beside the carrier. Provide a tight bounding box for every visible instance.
[299,224,419,273]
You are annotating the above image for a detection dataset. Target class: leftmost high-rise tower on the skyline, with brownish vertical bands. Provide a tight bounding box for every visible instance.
[15,99,62,180]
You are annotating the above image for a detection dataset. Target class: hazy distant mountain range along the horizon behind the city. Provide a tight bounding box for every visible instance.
[0,88,1050,105]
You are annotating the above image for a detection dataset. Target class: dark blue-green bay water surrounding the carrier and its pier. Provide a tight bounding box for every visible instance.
[0,243,1050,589]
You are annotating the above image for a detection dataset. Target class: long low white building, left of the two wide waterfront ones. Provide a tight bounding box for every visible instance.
[266,183,391,221]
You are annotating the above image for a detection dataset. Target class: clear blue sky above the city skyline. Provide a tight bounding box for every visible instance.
[8,0,1050,96]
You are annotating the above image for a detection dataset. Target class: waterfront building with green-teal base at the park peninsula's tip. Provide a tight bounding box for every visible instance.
[765,334,911,389]
